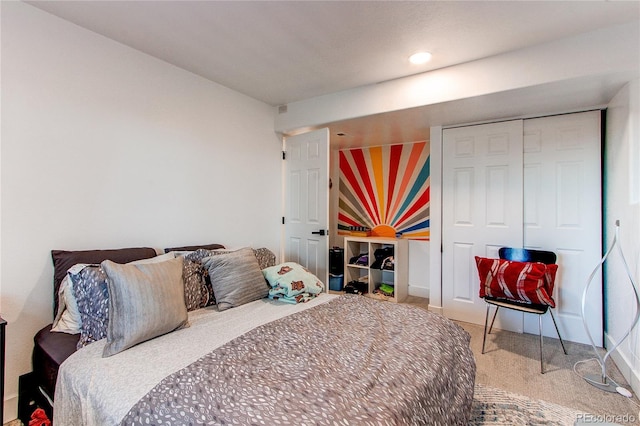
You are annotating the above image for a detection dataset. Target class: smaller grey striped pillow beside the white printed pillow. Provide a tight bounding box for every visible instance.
[202,248,269,311]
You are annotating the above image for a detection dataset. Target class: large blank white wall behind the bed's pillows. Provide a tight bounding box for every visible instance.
[0,2,281,421]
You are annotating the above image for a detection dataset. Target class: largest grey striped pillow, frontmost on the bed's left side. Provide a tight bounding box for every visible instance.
[101,257,187,357]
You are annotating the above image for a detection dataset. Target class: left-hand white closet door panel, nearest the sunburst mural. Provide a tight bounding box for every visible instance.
[442,120,523,331]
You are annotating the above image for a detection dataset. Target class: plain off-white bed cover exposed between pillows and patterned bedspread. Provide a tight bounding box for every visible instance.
[53,294,337,426]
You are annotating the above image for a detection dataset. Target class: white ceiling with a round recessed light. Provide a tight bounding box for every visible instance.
[27,0,640,146]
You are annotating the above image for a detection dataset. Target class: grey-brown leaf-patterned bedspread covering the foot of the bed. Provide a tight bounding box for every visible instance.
[121,296,475,425]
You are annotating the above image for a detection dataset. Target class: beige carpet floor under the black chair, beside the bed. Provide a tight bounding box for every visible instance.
[458,322,640,425]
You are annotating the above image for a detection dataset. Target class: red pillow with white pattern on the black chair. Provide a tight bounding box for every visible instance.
[476,256,558,308]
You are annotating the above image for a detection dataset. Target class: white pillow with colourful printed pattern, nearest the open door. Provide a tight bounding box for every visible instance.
[262,262,324,303]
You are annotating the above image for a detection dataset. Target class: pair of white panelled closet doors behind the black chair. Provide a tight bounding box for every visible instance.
[442,111,603,343]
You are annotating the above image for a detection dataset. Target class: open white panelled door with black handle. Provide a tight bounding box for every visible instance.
[284,128,329,289]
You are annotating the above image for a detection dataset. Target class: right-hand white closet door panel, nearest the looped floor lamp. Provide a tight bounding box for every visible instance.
[524,111,603,343]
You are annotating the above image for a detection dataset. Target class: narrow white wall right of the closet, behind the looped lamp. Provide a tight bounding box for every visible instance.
[604,80,640,394]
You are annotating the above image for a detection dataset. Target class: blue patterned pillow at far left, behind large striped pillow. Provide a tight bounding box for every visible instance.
[69,265,109,349]
